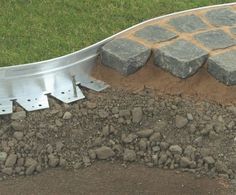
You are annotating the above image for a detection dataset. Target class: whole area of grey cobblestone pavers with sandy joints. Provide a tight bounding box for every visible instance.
[101,6,236,85]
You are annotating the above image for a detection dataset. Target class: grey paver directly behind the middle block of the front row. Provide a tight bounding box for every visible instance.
[194,30,236,50]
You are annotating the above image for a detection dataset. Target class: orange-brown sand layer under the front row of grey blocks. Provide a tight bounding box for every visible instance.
[93,59,236,104]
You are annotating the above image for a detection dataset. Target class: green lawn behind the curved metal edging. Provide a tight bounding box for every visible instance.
[0,0,234,67]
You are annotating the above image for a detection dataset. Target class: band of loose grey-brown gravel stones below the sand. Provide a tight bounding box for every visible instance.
[0,89,236,185]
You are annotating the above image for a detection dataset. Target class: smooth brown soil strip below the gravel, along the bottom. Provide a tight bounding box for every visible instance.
[0,162,230,195]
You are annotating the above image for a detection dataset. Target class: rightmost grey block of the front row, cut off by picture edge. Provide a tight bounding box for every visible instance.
[208,50,236,85]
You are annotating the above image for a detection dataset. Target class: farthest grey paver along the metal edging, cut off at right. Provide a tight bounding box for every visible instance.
[205,8,236,26]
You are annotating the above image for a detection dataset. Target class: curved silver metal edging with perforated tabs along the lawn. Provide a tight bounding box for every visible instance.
[0,2,236,115]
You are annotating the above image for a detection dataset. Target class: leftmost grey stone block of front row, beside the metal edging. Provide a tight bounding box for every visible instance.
[101,38,151,75]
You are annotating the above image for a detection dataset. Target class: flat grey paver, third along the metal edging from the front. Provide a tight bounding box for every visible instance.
[169,14,207,33]
